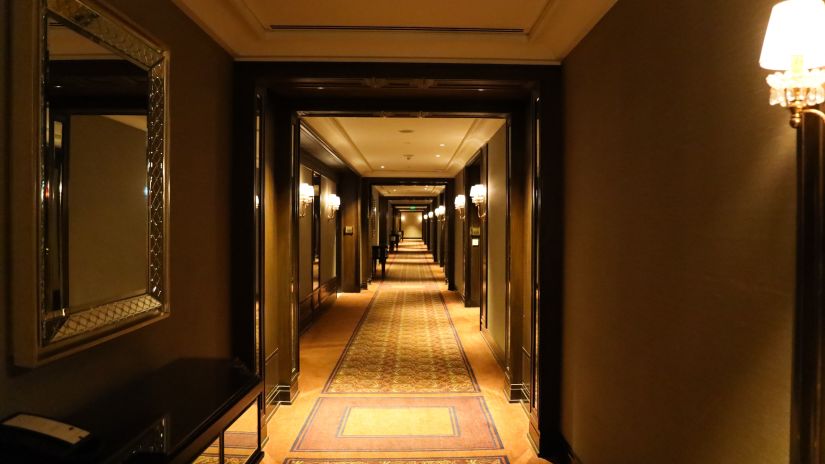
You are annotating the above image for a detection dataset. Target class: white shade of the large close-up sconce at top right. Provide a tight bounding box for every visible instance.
[759,0,825,71]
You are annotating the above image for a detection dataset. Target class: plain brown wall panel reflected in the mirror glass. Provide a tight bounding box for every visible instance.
[64,115,149,308]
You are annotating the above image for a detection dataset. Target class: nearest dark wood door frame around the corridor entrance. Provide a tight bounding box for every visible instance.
[233,62,568,461]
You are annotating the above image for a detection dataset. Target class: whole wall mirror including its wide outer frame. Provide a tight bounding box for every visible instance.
[11,0,169,367]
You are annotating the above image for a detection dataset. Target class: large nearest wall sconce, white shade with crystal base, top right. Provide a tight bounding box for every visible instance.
[759,0,825,128]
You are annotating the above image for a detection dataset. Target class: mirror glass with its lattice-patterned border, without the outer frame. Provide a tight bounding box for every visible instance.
[40,0,168,345]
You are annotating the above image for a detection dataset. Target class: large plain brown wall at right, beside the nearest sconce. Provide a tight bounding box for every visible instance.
[563,0,796,464]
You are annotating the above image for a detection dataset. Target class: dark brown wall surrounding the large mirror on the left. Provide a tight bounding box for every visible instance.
[0,0,238,416]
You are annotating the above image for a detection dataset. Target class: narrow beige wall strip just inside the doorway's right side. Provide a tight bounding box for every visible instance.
[487,125,507,353]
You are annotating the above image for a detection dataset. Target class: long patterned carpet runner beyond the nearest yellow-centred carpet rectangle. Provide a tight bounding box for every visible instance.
[324,242,479,394]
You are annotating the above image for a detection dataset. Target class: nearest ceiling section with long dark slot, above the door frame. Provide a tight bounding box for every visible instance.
[174,0,616,64]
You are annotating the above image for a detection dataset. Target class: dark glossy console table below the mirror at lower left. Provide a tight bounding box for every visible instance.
[4,359,263,464]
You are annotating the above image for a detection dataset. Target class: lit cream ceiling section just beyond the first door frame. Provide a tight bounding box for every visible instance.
[302,117,498,179]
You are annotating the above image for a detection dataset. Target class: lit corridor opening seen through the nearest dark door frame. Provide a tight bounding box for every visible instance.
[264,112,530,464]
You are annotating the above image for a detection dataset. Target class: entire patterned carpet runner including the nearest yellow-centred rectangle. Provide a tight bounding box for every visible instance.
[284,240,508,458]
